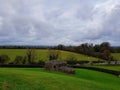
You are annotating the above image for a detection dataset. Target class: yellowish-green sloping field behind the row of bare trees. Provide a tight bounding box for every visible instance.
[0,49,100,61]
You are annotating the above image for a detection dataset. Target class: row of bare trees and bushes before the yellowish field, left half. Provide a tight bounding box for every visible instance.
[0,49,60,66]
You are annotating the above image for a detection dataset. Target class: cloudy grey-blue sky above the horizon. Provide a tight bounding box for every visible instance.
[0,0,120,46]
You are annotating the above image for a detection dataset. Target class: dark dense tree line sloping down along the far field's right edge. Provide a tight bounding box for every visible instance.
[55,42,120,60]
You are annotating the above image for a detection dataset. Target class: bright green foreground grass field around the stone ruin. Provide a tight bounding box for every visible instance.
[0,68,120,90]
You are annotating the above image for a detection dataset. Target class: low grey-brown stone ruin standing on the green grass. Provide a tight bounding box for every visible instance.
[45,60,75,74]
